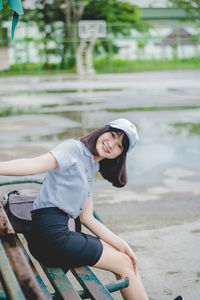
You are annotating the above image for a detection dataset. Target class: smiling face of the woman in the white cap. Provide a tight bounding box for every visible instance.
[94,131,124,162]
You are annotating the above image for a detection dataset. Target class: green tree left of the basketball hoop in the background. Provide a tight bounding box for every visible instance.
[22,0,87,67]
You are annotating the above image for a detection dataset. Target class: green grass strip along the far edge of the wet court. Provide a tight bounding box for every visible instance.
[0,56,200,76]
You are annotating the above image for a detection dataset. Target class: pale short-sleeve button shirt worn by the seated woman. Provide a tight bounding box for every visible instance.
[33,139,99,218]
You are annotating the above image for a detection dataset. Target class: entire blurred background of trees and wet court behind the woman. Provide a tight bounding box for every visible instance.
[0,0,200,300]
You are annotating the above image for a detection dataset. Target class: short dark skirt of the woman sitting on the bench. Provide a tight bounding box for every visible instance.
[28,207,103,272]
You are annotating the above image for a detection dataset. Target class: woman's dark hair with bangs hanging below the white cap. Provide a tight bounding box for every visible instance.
[80,125,129,187]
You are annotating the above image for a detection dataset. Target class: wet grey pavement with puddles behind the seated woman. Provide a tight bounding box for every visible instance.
[0,70,200,300]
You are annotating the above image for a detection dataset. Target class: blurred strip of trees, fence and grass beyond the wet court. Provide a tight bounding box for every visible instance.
[0,0,200,74]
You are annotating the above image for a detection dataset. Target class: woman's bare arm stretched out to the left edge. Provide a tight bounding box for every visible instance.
[0,153,58,176]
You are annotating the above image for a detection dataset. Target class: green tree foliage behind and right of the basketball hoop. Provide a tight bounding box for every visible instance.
[83,0,150,53]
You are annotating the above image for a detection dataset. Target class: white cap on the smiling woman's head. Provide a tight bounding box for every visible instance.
[106,119,138,152]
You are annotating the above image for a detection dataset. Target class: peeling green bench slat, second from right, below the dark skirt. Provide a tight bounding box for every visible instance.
[41,264,81,300]
